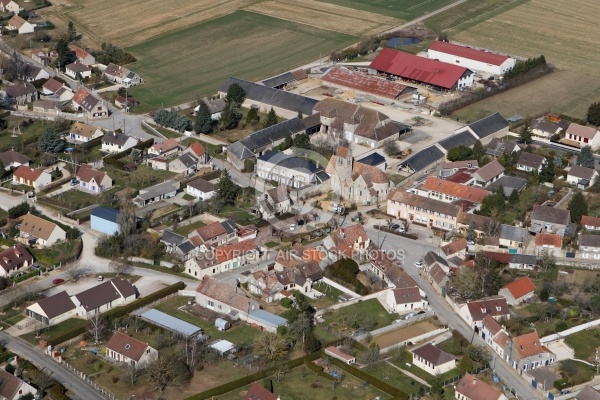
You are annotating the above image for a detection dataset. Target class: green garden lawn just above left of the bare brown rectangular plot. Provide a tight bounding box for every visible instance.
[323,299,398,334]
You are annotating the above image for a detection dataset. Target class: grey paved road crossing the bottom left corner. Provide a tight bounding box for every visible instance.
[0,332,104,400]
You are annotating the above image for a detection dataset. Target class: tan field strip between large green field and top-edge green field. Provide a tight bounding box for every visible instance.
[246,0,402,36]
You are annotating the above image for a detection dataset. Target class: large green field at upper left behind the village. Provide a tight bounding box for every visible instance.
[127,11,357,107]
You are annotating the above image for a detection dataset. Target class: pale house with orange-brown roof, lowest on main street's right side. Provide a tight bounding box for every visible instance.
[505,331,556,373]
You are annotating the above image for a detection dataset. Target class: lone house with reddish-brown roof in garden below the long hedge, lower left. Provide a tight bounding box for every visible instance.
[106,331,158,367]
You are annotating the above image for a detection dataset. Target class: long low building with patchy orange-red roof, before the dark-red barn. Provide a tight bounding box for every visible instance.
[321,67,417,100]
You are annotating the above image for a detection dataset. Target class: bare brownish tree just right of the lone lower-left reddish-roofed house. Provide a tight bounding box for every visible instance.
[146,354,192,393]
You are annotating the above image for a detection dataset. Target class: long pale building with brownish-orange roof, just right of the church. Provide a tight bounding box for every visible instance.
[387,189,462,231]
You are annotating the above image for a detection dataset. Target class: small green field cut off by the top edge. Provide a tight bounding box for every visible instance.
[323,0,452,21]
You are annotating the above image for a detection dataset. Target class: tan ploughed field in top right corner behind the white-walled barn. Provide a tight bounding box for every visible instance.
[452,0,600,76]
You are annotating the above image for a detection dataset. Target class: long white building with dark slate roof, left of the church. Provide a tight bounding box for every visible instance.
[256,151,325,188]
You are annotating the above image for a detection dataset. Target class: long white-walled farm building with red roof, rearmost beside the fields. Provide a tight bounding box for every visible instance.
[427,41,517,75]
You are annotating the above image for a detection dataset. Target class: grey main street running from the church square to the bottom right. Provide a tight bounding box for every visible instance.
[366,228,542,400]
